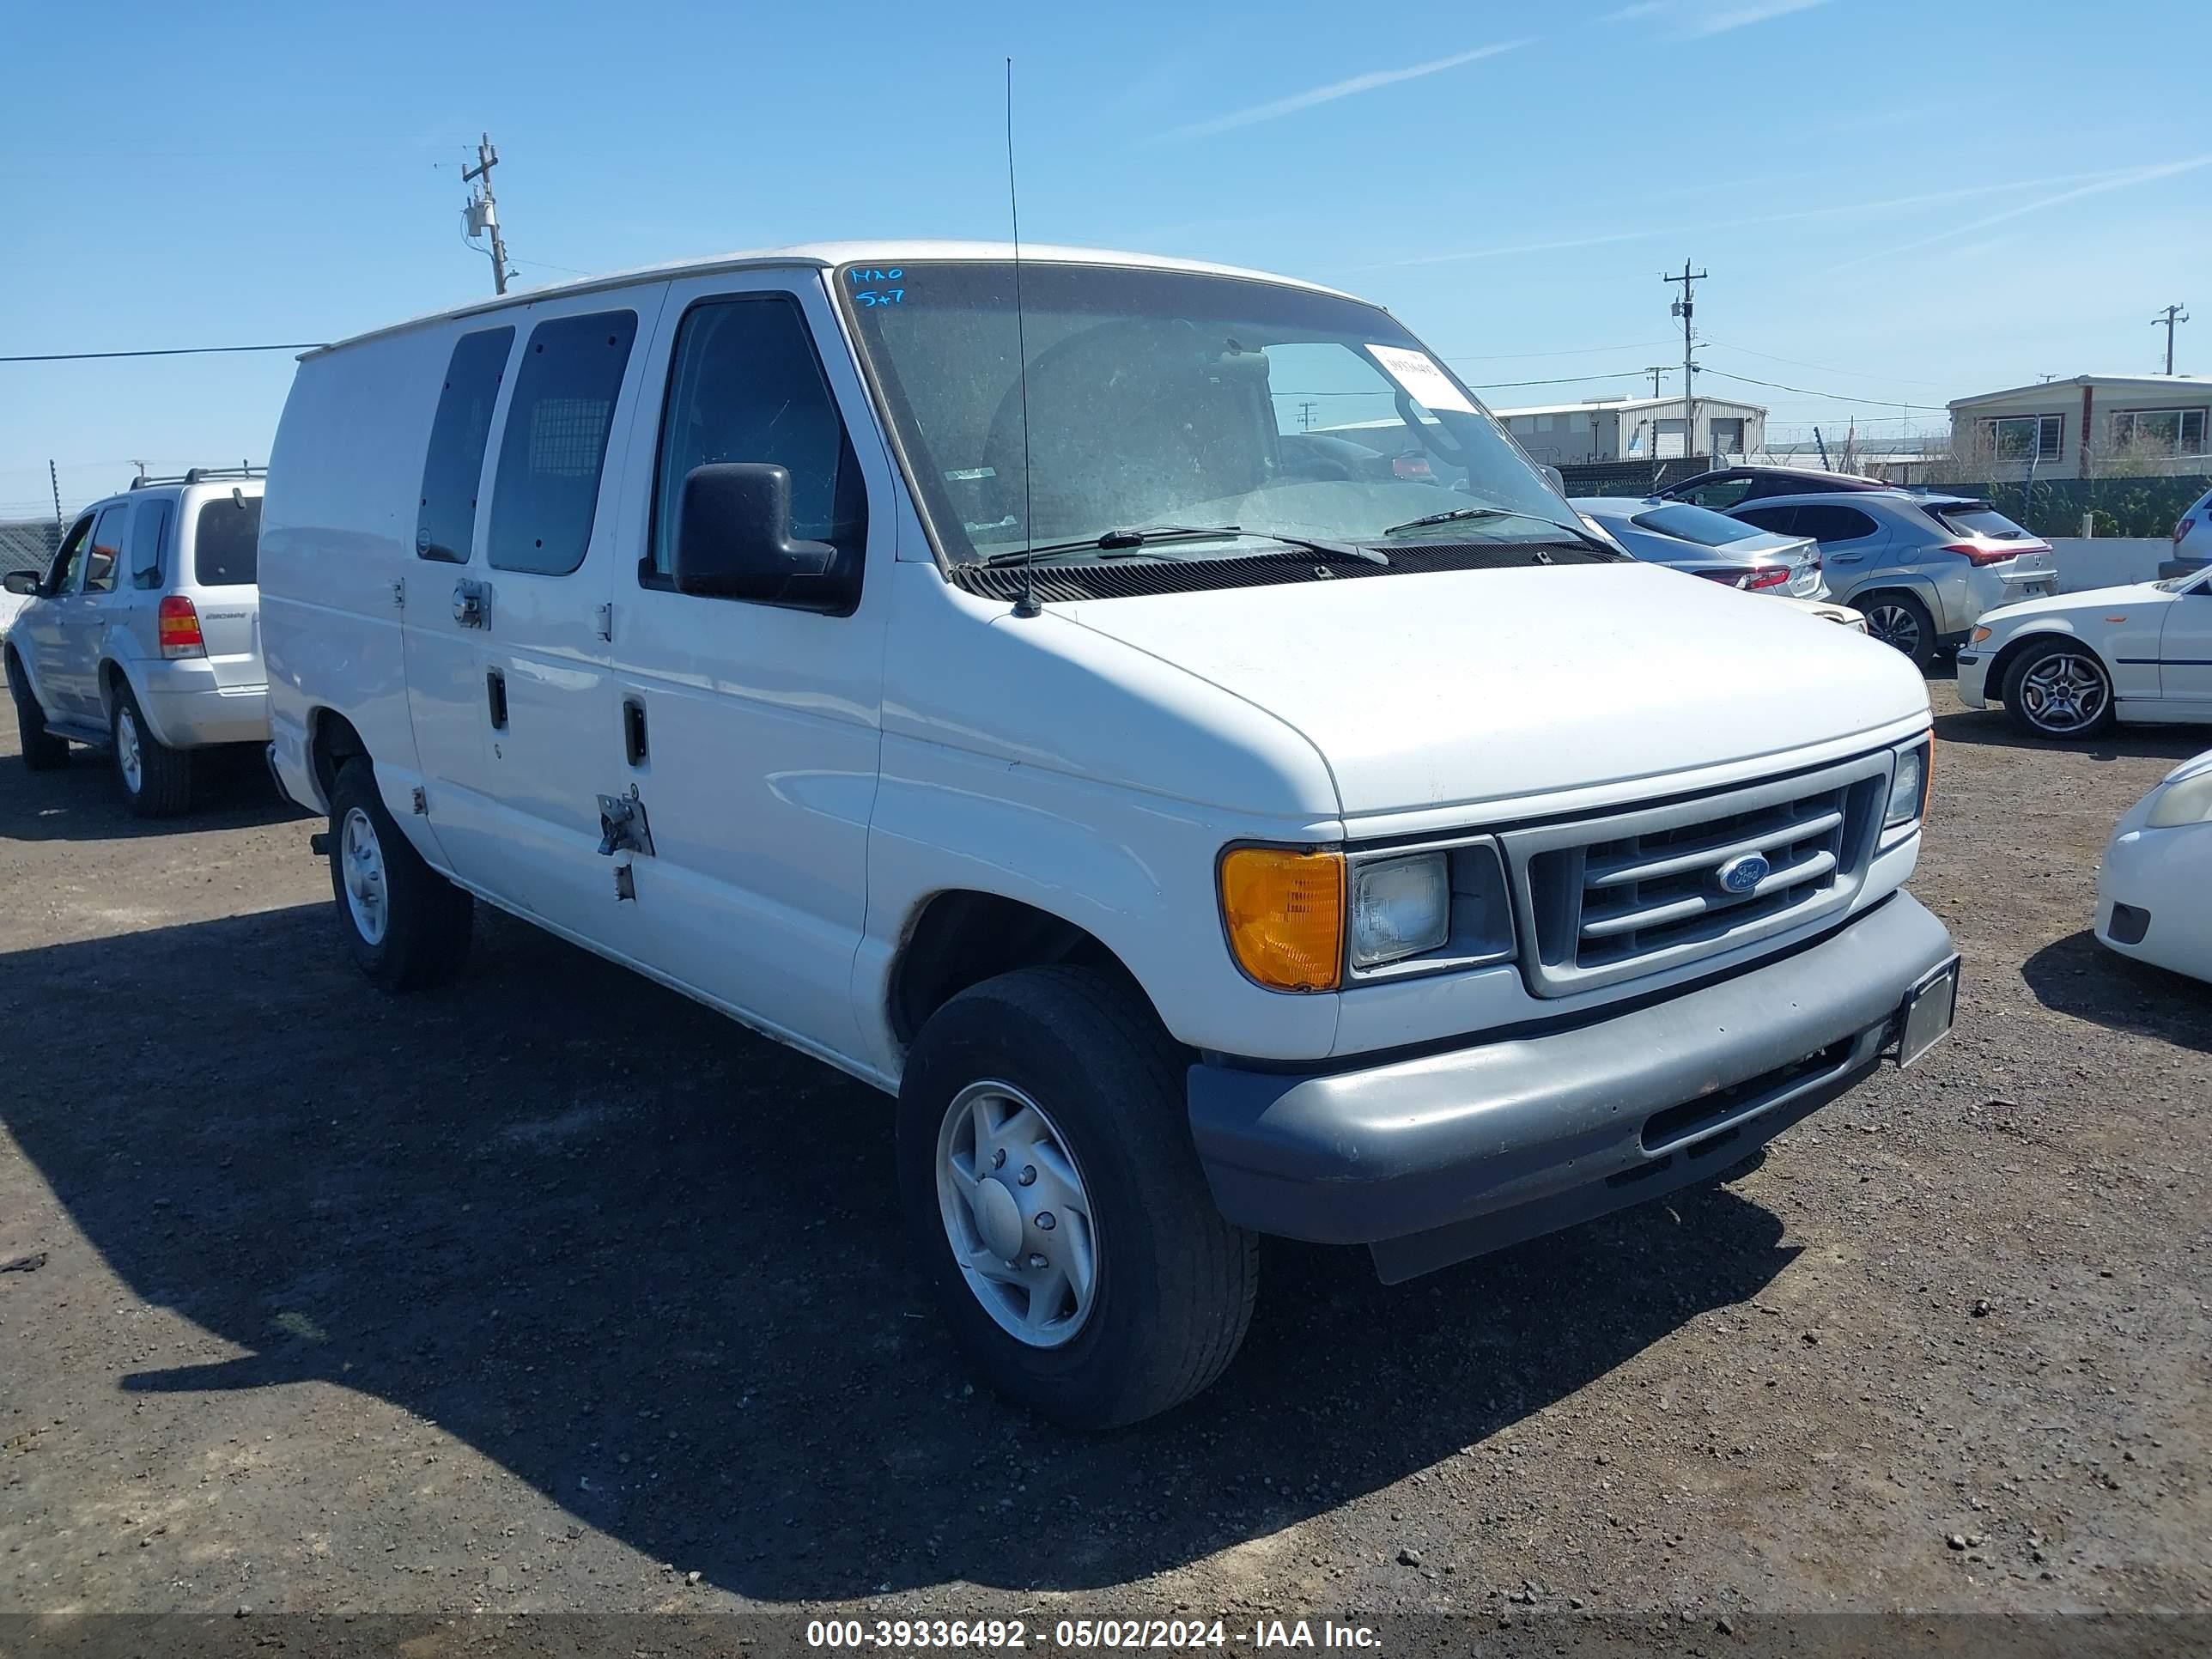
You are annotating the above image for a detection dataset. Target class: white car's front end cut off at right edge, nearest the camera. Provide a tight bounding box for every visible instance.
[2097,750,2212,980]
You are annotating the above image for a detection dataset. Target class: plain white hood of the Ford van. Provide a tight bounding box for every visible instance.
[1053,564,1929,817]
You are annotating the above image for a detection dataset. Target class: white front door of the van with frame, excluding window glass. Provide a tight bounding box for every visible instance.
[608,270,900,1060]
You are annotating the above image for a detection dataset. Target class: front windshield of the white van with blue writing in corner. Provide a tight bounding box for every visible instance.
[836,261,1586,564]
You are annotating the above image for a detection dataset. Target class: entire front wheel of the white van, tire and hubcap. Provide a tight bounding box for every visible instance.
[898,967,1259,1429]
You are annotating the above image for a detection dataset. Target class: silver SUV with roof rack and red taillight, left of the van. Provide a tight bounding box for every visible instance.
[4,469,270,818]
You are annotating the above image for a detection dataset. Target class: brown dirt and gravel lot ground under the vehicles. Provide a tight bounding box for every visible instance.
[0,684,2212,1646]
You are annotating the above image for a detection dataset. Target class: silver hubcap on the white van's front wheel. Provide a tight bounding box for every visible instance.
[938,1082,1097,1347]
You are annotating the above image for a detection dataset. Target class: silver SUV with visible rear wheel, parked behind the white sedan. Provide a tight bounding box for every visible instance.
[1725,489,2059,668]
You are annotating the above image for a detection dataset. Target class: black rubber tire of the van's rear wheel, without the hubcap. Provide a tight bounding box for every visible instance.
[330,757,476,994]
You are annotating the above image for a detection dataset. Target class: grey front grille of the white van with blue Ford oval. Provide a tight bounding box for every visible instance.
[1502,752,1891,998]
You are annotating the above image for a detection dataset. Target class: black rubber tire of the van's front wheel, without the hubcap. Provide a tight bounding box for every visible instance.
[898,967,1259,1429]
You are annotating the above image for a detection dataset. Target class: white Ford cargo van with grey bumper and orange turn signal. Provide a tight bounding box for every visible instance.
[261,243,1958,1425]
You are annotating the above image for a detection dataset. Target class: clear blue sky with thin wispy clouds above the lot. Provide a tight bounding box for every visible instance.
[0,0,2212,518]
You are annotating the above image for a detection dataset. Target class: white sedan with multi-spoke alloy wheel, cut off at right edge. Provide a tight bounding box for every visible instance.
[1958,566,2212,737]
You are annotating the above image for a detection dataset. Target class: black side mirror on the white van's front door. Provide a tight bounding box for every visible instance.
[671,460,849,611]
